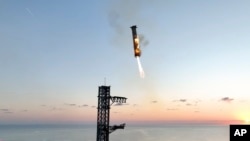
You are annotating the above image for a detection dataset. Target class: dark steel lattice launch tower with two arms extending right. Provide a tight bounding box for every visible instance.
[96,86,127,141]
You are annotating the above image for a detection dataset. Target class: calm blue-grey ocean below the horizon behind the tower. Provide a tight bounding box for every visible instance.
[0,125,229,141]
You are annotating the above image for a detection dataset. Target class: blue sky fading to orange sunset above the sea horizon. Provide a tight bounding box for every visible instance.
[0,0,250,124]
